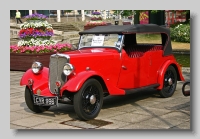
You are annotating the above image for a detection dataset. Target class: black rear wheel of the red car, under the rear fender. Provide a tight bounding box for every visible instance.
[159,66,177,98]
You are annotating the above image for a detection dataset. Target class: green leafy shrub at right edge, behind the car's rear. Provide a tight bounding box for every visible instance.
[170,24,190,43]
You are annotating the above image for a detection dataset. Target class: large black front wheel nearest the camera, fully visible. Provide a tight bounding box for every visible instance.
[74,79,103,120]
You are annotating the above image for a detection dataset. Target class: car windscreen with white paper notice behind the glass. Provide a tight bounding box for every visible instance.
[79,34,123,49]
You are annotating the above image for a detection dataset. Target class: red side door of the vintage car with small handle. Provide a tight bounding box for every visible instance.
[118,50,148,89]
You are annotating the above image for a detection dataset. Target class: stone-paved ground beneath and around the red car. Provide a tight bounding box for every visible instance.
[10,68,191,130]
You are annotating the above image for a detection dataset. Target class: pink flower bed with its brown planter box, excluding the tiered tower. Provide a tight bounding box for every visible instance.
[10,43,72,71]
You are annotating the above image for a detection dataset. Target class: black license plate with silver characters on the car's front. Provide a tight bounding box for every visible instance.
[33,95,58,106]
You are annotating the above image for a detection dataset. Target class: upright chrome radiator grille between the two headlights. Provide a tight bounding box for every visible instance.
[49,54,69,94]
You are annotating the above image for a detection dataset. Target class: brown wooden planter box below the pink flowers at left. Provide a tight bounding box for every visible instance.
[10,52,54,71]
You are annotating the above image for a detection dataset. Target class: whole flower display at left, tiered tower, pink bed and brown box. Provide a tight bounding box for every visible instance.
[10,14,72,71]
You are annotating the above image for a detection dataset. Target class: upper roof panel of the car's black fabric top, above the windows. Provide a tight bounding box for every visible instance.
[79,24,170,35]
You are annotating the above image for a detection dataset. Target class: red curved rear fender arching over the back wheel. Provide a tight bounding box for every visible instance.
[157,60,185,89]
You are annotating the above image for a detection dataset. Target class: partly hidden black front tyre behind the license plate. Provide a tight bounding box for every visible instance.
[25,86,50,113]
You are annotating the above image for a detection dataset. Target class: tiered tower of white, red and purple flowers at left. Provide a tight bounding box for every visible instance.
[17,14,57,46]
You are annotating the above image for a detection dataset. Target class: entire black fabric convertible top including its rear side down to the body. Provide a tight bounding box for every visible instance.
[79,24,172,55]
